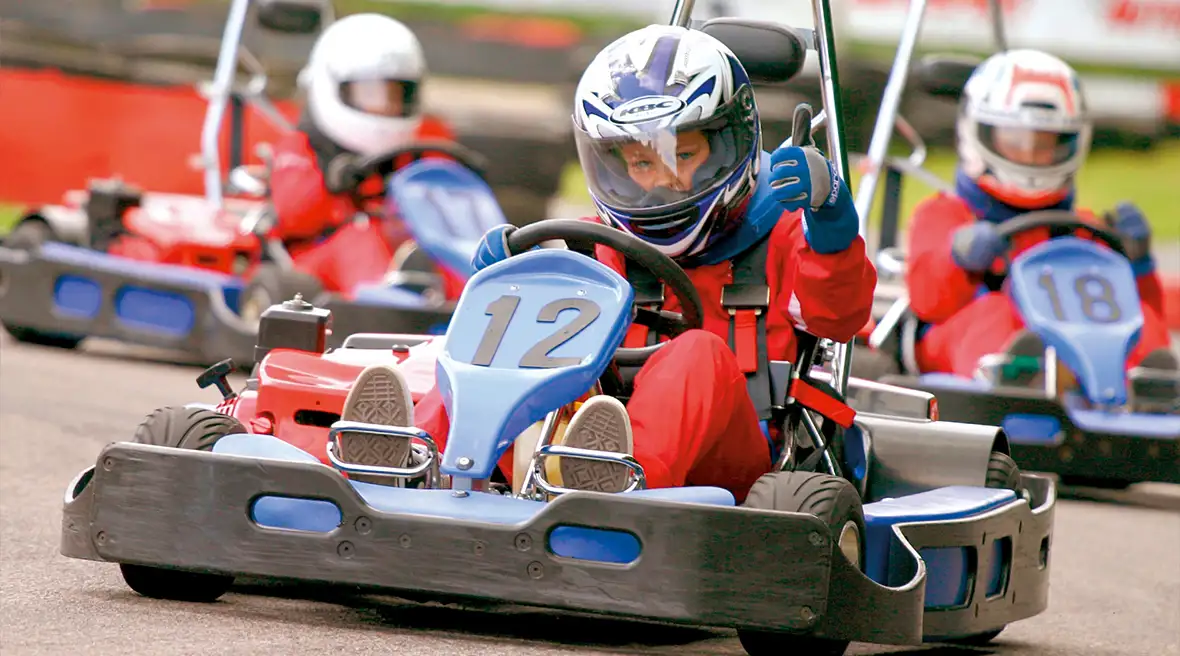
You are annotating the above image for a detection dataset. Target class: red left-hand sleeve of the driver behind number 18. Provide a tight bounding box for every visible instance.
[905,193,979,323]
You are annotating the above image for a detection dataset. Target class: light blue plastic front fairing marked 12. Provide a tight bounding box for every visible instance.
[437,249,635,479]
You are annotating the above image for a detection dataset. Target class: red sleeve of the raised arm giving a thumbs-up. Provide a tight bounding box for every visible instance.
[767,212,877,342]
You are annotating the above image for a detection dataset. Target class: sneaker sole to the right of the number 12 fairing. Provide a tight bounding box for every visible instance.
[559,395,634,492]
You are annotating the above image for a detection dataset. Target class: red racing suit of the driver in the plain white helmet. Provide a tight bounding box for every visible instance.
[270,117,464,300]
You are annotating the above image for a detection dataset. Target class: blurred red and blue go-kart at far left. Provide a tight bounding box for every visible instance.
[0,0,505,366]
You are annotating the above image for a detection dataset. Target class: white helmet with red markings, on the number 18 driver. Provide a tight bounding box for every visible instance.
[957,50,1093,209]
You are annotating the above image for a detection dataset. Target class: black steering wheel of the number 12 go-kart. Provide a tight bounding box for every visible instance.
[509,218,704,366]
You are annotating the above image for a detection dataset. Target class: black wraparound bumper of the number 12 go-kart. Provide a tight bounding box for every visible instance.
[61,442,1054,644]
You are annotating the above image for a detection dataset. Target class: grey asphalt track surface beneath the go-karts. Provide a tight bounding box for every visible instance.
[0,334,1180,656]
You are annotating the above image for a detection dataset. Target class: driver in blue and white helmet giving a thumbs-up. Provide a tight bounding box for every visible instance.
[345,26,877,500]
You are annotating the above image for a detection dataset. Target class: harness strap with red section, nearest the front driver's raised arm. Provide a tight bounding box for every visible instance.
[721,235,774,420]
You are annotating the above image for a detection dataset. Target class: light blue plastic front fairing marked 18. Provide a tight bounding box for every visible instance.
[1009,237,1143,405]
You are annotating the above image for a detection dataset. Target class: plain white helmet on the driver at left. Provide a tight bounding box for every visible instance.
[299,14,426,156]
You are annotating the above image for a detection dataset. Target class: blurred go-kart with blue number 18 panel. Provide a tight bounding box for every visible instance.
[853,10,1180,487]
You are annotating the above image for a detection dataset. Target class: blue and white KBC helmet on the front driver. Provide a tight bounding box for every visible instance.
[573,25,762,257]
